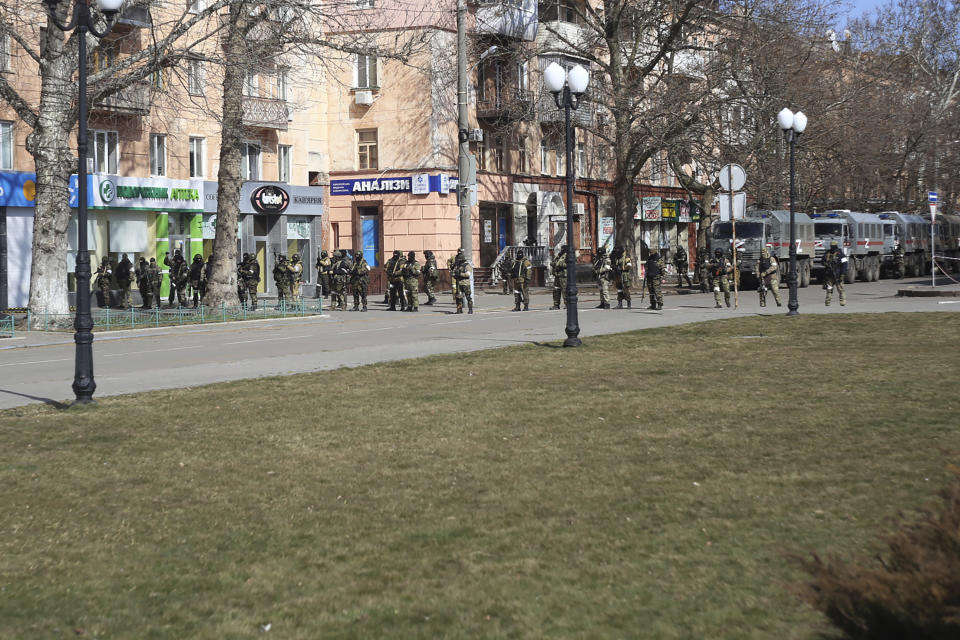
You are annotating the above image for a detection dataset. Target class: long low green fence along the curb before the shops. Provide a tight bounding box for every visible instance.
[26,300,323,335]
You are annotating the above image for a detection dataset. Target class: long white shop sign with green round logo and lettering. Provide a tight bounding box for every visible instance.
[90,174,203,211]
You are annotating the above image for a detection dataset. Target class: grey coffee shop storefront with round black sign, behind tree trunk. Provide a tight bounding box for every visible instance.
[200,182,325,297]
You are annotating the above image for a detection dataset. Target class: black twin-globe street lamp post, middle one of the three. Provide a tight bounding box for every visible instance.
[543,62,590,347]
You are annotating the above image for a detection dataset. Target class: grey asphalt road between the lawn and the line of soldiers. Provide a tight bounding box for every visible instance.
[0,279,960,409]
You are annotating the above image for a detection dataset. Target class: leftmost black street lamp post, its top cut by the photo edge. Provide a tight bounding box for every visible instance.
[45,0,123,404]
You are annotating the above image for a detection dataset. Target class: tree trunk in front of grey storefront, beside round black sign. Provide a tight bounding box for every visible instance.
[203,2,251,306]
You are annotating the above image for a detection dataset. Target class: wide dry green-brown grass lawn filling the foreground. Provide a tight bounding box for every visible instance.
[0,313,960,639]
